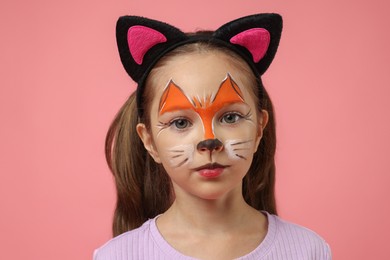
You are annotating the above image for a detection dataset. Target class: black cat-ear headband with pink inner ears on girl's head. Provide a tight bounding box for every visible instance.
[116,13,282,116]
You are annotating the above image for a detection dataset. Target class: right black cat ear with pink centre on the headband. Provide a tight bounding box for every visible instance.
[214,13,283,75]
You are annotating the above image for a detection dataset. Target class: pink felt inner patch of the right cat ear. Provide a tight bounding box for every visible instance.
[230,28,271,63]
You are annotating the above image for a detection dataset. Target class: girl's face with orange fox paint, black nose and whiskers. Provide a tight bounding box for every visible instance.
[137,52,268,199]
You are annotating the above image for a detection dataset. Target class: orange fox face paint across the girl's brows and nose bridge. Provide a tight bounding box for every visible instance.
[159,74,244,139]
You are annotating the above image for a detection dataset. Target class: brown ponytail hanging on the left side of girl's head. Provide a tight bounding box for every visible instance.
[105,94,172,236]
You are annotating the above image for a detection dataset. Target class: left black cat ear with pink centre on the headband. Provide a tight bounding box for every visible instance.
[116,16,187,82]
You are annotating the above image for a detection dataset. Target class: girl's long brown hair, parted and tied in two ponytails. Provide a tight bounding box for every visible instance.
[106,42,277,236]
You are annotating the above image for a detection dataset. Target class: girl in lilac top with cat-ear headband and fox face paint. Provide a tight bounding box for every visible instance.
[94,14,331,260]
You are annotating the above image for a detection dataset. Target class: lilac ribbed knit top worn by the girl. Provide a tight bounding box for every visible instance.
[94,212,332,260]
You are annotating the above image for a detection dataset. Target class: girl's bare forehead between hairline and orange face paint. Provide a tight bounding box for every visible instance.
[153,52,254,97]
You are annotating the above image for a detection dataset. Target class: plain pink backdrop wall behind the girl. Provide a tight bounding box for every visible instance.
[0,0,390,260]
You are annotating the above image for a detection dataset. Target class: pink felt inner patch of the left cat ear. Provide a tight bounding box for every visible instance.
[127,25,167,65]
